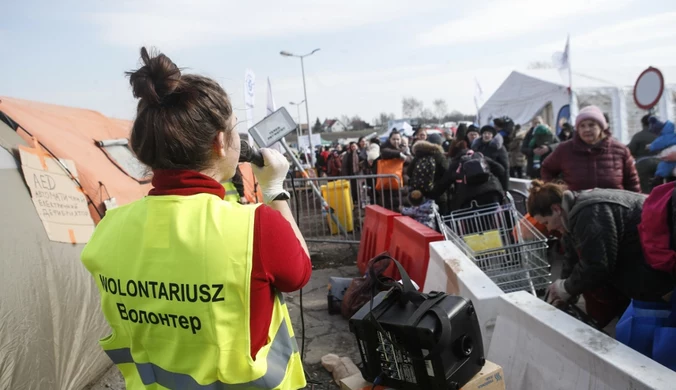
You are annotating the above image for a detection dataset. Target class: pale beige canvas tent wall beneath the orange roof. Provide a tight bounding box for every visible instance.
[0,122,111,389]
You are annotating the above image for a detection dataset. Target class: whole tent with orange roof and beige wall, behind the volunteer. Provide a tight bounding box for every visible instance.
[0,98,149,390]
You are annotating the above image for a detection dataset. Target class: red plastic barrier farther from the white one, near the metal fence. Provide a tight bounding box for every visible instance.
[357,205,401,275]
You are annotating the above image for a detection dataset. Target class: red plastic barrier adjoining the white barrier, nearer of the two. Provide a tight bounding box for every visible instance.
[385,217,444,291]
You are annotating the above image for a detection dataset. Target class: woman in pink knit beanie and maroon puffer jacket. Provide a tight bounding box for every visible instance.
[541,106,641,192]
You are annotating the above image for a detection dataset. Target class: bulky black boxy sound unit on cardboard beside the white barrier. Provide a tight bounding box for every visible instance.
[350,260,486,390]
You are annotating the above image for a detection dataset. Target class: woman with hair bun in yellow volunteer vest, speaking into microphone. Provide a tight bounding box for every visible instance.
[82,48,312,390]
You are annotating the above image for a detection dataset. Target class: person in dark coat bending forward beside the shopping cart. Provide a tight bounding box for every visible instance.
[528,180,674,326]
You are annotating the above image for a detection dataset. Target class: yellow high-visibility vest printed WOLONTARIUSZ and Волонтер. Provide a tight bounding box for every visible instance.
[82,194,306,390]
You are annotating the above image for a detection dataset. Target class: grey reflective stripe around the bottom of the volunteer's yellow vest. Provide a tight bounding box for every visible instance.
[106,322,298,390]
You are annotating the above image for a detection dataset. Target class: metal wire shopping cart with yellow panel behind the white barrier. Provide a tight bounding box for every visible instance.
[438,193,551,296]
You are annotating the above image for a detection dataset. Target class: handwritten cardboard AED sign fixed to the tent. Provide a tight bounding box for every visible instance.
[19,145,94,244]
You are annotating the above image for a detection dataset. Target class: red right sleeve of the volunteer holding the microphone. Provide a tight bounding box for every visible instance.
[254,205,312,292]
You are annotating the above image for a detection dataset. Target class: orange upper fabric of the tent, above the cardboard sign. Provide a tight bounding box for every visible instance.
[0,97,150,223]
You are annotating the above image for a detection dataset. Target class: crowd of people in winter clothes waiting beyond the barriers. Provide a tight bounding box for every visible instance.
[308,106,676,342]
